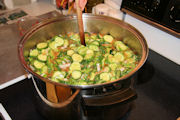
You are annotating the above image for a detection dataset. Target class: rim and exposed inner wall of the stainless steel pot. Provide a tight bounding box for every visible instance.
[18,14,148,88]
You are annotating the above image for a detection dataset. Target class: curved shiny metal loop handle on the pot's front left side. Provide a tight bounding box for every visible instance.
[31,75,80,108]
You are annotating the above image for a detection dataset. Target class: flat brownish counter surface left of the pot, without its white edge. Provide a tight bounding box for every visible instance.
[0,11,60,84]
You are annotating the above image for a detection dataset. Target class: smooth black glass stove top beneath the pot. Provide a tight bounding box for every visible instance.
[0,50,180,120]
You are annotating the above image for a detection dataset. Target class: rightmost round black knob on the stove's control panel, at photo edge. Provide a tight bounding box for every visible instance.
[169,4,180,23]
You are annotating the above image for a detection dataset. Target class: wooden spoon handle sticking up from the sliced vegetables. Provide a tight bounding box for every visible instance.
[75,0,86,45]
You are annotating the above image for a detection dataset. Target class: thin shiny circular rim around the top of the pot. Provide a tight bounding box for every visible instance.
[18,13,149,89]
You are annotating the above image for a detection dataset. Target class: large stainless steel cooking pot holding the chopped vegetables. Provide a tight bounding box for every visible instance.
[18,14,148,119]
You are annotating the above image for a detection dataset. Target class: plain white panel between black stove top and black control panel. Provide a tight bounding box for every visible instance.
[125,14,180,65]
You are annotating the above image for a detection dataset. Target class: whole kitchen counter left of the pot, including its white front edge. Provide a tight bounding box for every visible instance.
[0,2,61,90]
